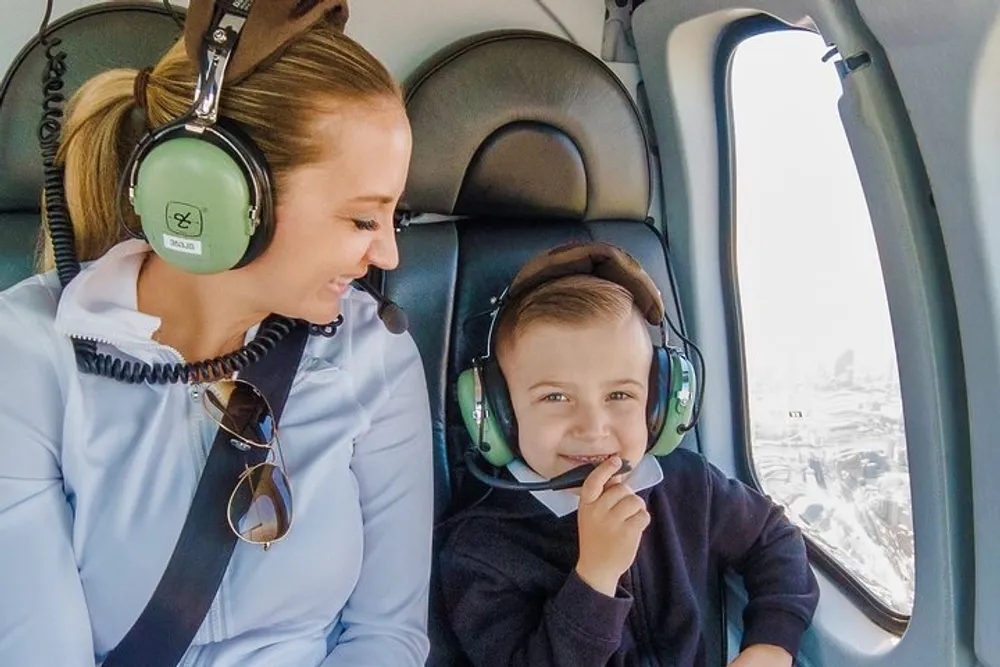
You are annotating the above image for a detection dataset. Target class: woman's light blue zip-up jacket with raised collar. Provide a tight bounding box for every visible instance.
[0,241,433,667]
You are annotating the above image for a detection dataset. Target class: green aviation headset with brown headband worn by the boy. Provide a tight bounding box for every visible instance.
[457,242,700,480]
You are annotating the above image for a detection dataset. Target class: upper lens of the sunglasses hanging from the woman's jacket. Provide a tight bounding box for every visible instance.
[201,380,274,447]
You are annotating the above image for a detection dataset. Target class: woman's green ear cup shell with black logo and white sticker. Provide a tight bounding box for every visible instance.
[135,137,254,273]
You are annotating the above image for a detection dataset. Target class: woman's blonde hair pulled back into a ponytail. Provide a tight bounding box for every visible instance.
[39,12,402,270]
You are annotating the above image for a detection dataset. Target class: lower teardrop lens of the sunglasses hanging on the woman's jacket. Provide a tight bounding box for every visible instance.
[229,463,292,544]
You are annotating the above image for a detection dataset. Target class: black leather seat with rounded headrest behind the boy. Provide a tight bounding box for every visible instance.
[385,31,712,667]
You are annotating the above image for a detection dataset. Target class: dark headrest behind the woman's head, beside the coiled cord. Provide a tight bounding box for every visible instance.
[0,2,183,212]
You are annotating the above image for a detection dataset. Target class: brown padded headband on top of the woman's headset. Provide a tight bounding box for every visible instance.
[184,0,348,85]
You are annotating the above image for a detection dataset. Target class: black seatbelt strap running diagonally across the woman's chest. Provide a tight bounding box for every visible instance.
[102,326,309,667]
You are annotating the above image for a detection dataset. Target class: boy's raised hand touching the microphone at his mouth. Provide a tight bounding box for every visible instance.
[576,456,649,597]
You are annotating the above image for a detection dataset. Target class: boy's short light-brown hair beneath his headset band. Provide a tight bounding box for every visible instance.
[494,274,641,355]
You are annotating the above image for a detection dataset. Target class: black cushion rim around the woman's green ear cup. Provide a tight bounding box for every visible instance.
[134,116,274,269]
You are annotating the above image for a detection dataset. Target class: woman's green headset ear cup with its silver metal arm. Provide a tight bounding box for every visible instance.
[125,2,274,274]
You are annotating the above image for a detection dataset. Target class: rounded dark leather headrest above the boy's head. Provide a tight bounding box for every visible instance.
[401,30,651,220]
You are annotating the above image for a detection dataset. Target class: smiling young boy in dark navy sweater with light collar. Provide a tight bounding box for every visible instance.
[440,244,818,667]
